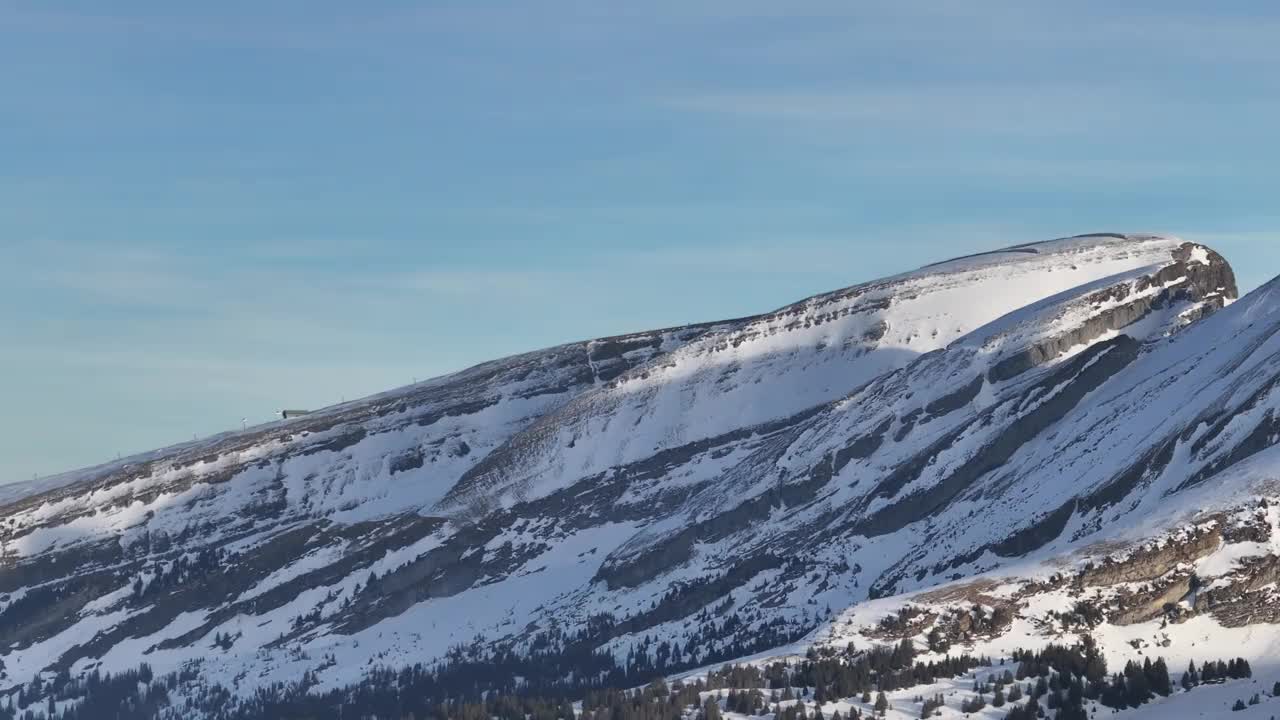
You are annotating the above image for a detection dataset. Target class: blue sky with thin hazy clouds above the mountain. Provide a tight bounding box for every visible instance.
[0,0,1280,483]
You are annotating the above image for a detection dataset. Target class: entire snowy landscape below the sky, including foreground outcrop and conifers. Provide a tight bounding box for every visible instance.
[0,233,1280,720]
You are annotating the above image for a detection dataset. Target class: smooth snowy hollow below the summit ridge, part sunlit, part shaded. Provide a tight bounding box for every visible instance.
[440,236,1218,511]
